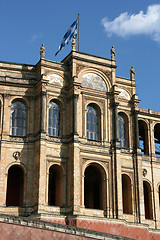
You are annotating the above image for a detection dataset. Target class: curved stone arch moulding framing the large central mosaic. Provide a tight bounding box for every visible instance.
[78,68,111,91]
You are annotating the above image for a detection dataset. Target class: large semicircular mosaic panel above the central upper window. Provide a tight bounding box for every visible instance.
[81,73,107,92]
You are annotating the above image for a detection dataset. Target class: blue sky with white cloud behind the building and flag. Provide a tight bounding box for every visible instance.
[0,0,160,110]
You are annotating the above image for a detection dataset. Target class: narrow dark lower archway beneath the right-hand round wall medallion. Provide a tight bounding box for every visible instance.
[143,181,153,219]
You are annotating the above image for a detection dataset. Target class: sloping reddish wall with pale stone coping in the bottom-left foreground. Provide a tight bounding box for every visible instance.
[0,215,133,240]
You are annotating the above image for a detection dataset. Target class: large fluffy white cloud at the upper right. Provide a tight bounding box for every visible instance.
[102,4,160,42]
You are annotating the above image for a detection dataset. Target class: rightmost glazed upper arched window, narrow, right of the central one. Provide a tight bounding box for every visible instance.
[118,114,127,148]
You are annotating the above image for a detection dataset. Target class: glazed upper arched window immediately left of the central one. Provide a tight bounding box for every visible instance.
[48,101,60,137]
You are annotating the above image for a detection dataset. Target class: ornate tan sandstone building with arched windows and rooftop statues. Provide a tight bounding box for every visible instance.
[0,40,160,239]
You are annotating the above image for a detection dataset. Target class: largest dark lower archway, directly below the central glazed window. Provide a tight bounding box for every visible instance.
[84,164,105,209]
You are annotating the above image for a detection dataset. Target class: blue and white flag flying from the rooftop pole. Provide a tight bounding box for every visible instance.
[55,19,78,55]
